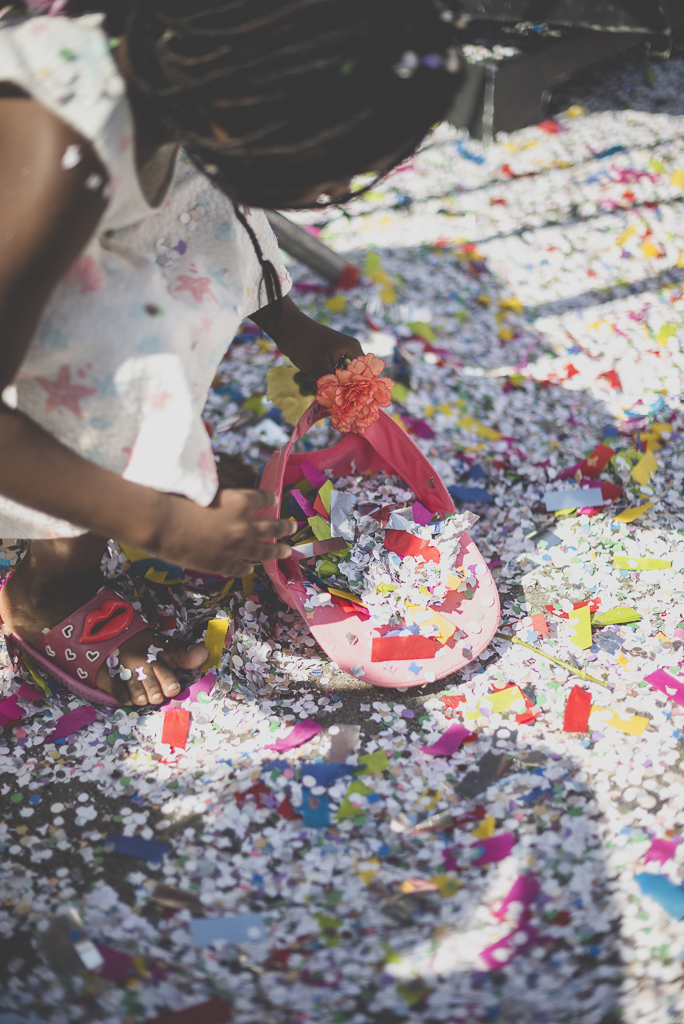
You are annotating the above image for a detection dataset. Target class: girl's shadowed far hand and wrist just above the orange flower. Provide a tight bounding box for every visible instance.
[251,295,364,381]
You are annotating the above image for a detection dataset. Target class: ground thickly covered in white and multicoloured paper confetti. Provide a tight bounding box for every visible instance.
[9,44,684,1024]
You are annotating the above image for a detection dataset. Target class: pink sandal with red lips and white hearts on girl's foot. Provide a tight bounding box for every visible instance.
[5,577,149,708]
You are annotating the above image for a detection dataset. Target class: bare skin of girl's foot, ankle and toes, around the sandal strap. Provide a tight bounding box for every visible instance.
[0,534,208,707]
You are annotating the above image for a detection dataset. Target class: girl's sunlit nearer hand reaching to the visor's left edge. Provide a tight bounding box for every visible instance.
[150,489,297,577]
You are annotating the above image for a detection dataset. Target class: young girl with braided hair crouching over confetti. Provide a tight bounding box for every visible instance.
[0,0,460,705]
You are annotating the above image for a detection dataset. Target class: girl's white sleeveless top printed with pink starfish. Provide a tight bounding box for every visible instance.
[0,15,291,539]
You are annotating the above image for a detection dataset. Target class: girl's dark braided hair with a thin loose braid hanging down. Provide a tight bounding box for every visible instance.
[69,0,461,302]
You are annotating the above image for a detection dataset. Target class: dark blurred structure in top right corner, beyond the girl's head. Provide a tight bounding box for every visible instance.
[447,0,684,141]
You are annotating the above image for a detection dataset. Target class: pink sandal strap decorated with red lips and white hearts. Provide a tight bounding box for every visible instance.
[36,587,149,687]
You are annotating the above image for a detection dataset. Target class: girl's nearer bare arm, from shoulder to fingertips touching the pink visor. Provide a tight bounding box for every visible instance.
[0,96,292,575]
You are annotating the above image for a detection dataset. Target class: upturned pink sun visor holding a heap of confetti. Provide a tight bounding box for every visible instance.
[255,402,500,686]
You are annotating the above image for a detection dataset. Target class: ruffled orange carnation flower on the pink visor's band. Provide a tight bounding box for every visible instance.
[316,354,394,434]
